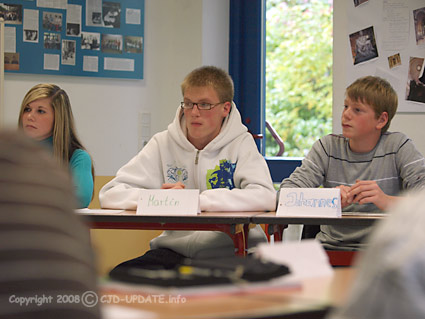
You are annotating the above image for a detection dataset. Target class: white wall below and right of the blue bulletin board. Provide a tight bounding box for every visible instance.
[4,0,229,175]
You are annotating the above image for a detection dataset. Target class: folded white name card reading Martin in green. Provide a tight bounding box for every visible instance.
[136,189,200,215]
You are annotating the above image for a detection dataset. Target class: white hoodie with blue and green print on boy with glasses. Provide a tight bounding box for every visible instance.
[99,103,276,257]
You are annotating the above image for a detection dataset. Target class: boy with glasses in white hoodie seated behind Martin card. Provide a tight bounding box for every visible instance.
[99,66,276,267]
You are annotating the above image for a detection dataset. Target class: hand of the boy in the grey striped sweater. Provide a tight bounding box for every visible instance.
[347,180,395,210]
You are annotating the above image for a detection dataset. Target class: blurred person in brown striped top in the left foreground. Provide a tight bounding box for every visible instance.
[0,131,100,319]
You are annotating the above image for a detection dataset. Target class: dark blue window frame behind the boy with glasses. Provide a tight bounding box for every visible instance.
[229,0,302,183]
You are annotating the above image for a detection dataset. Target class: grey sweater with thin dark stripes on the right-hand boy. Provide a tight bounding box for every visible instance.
[280,132,425,249]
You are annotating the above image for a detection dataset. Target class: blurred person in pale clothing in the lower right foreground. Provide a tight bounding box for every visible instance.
[328,190,425,319]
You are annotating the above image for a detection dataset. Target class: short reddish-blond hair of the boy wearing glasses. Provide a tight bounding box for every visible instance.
[181,66,234,102]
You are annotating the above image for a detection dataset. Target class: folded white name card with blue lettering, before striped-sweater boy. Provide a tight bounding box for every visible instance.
[276,188,341,217]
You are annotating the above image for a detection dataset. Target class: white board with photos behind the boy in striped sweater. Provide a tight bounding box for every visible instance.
[345,0,425,112]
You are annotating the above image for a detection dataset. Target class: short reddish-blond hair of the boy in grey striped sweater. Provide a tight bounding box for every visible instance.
[345,76,398,133]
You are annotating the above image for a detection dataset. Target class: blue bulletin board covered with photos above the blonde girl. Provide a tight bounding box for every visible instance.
[0,0,145,79]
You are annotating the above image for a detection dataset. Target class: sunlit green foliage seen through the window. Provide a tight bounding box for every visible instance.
[266,0,333,157]
